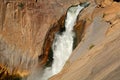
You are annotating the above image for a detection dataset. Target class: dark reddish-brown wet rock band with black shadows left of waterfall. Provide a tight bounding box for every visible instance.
[39,15,65,65]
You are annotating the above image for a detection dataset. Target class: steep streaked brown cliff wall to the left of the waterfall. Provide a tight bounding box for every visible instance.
[0,0,84,75]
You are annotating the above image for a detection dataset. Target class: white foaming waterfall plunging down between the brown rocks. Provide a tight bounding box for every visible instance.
[28,3,88,80]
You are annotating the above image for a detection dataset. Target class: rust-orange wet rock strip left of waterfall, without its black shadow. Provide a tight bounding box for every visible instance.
[39,15,66,64]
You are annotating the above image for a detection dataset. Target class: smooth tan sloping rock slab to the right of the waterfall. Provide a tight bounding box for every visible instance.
[50,2,120,80]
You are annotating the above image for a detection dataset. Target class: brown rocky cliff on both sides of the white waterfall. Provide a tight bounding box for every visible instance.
[0,0,120,80]
